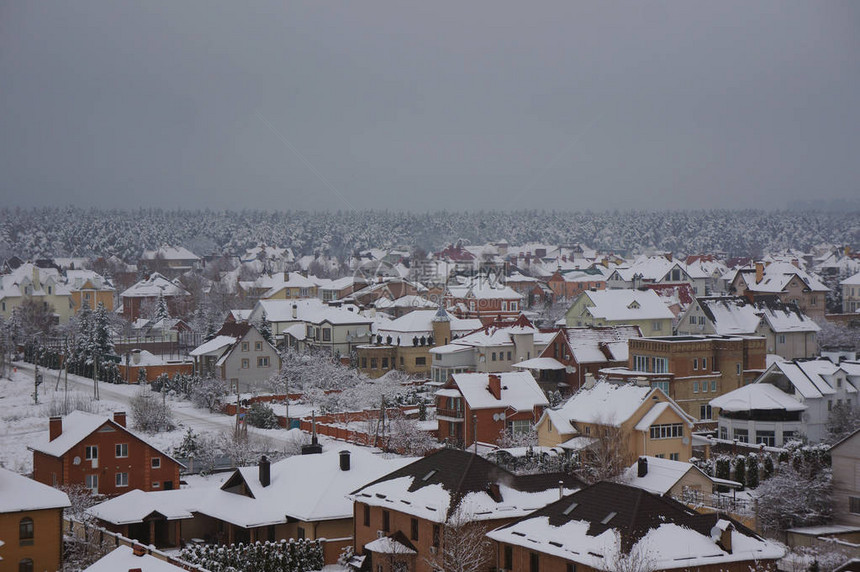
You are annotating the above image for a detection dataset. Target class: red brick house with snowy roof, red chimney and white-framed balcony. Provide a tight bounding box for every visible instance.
[436,371,549,448]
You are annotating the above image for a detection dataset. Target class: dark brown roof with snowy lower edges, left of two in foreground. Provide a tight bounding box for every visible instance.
[351,449,581,523]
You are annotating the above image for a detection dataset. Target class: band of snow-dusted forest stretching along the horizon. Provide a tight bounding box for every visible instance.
[0,207,860,259]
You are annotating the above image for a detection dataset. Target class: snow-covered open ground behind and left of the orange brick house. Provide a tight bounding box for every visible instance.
[0,362,342,474]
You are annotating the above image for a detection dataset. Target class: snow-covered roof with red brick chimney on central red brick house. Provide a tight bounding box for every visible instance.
[452,371,549,411]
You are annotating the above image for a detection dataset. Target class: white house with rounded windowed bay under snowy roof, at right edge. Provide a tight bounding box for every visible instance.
[711,359,860,447]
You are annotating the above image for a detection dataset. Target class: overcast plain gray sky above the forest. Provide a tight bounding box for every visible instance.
[0,0,860,210]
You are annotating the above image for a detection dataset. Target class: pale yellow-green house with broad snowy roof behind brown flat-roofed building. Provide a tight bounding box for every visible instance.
[564,290,675,336]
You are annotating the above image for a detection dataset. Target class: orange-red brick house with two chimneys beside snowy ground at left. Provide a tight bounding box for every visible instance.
[29,411,183,496]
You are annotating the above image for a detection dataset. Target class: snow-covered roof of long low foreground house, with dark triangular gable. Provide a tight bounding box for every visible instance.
[89,446,414,528]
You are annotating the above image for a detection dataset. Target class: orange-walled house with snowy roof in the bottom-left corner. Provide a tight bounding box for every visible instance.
[0,467,71,572]
